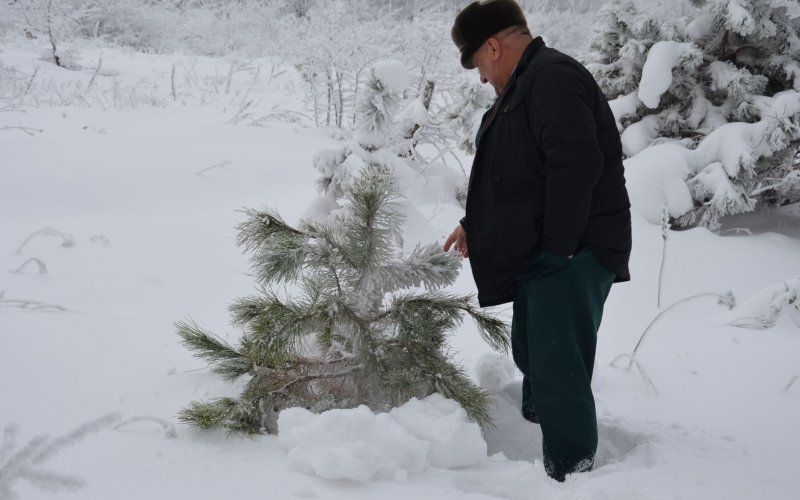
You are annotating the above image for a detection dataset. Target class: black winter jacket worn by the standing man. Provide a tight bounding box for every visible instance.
[462,37,631,307]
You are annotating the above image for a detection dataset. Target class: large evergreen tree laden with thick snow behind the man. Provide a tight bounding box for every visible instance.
[590,0,800,229]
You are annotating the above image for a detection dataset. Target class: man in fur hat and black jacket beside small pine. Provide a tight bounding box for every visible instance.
[444,0,631,481]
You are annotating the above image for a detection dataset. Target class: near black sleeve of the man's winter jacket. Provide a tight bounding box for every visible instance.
[527,63,604,257]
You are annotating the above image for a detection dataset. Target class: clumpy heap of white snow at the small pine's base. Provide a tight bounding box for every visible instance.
[278,394,487,482]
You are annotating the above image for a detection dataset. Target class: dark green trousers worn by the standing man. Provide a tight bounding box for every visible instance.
[511,249,615,481]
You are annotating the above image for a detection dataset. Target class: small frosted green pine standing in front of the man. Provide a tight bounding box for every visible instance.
[177,174,509,433]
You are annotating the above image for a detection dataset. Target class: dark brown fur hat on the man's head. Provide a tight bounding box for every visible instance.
[450,0,528,69]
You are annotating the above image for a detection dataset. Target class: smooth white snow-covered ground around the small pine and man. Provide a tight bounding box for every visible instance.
[0,45,800,500]
